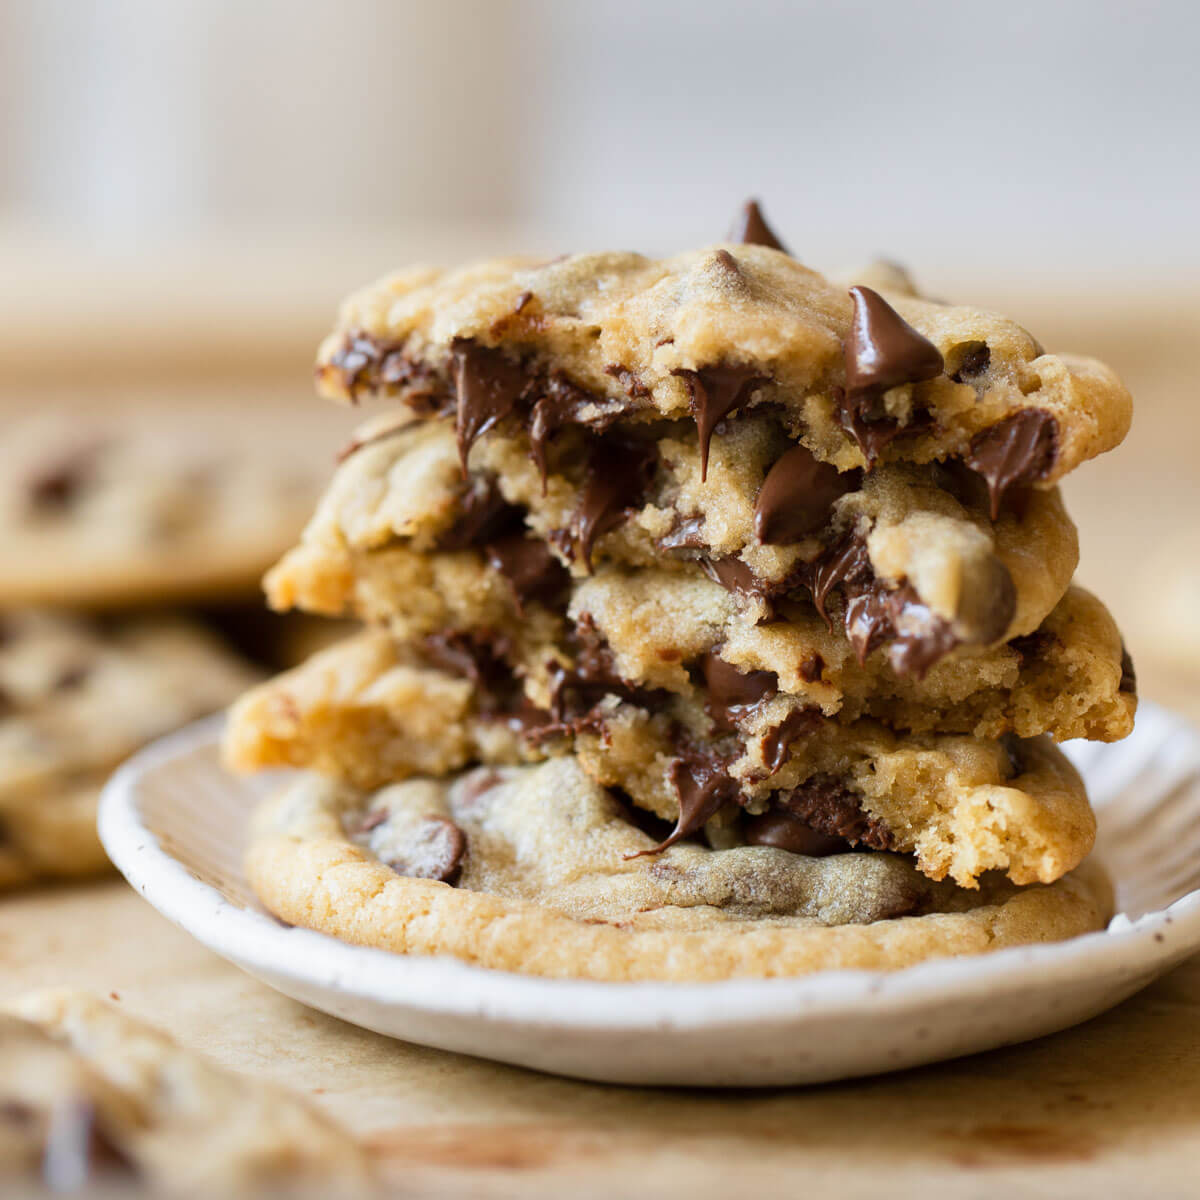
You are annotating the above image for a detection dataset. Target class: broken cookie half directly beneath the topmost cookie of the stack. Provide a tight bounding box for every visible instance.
[268,414,1079,674]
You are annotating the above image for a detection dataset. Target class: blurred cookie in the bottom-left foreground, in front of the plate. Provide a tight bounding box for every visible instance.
[0,991,370,1196]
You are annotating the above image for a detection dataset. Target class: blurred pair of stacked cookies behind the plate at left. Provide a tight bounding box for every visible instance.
[0,403,343,888]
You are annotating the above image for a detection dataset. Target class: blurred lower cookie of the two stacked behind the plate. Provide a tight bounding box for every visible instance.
[0,610,258,888]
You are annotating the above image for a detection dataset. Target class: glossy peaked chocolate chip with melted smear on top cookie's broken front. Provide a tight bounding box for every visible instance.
[835,287,943,466]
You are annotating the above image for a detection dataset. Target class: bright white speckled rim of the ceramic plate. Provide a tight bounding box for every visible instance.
[98,703,1200,1032]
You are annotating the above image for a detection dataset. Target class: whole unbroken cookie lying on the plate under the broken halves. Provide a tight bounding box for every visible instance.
[246,757,1111,982]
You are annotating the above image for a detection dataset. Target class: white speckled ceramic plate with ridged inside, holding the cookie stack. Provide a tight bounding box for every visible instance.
[100,704,1200,1087]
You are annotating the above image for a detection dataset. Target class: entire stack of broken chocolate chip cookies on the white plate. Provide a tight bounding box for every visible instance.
[227,205,1136,979]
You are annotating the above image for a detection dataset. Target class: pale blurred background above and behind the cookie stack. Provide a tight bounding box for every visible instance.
[0,0,1200,697]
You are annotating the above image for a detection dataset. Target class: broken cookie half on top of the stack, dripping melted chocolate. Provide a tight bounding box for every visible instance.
[317,242,1130,511]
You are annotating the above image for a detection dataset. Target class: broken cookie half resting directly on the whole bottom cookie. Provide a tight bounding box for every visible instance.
[226,632,1096,887]
